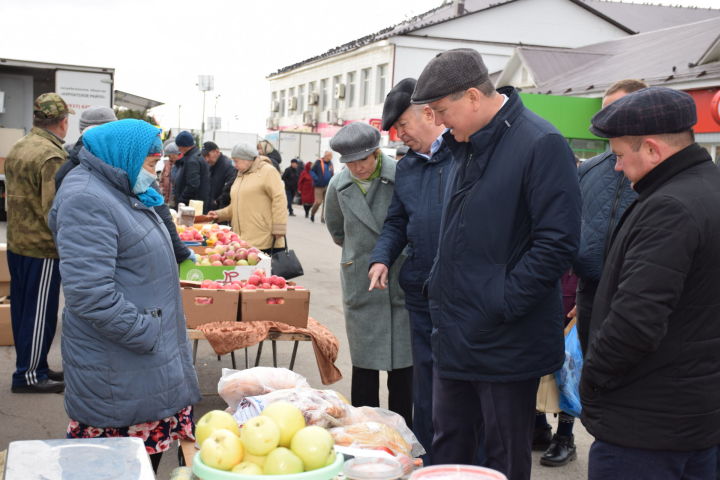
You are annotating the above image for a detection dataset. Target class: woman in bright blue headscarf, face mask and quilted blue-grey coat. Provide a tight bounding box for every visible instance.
[49,119,200,471]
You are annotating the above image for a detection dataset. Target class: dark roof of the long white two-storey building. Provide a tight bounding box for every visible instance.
[268,0,720,77]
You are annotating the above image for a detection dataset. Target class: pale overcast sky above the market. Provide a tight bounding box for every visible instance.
[0,0,720,133]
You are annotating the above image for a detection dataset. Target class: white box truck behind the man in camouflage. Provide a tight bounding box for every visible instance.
[0,58,115,220]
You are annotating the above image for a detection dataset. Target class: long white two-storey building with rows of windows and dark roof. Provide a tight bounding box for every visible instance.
[267,0,707,148]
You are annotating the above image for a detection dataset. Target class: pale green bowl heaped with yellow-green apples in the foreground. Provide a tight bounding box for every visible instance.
[192,402,344,480]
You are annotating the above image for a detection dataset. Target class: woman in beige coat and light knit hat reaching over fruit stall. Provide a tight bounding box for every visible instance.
[208,143,288,251]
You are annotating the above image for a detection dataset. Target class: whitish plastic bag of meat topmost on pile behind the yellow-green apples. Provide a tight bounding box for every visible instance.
[218,367,310,413]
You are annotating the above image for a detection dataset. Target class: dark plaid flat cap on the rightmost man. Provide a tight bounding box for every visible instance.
[590,87,697,138]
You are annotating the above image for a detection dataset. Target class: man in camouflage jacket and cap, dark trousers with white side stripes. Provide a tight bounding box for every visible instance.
[5,93,75,393]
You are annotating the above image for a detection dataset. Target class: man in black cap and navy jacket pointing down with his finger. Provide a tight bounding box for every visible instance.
[368,78,452,465]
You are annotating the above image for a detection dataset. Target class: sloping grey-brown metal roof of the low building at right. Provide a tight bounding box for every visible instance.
[516,17,720,95]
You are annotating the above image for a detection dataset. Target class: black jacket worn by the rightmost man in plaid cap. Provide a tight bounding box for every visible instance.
[580,144,720,451]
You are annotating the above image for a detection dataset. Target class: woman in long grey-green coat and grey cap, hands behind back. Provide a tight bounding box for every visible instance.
[325,123,414,426]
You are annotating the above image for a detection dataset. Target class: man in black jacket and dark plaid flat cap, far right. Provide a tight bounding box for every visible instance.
[580,87,720,480]
